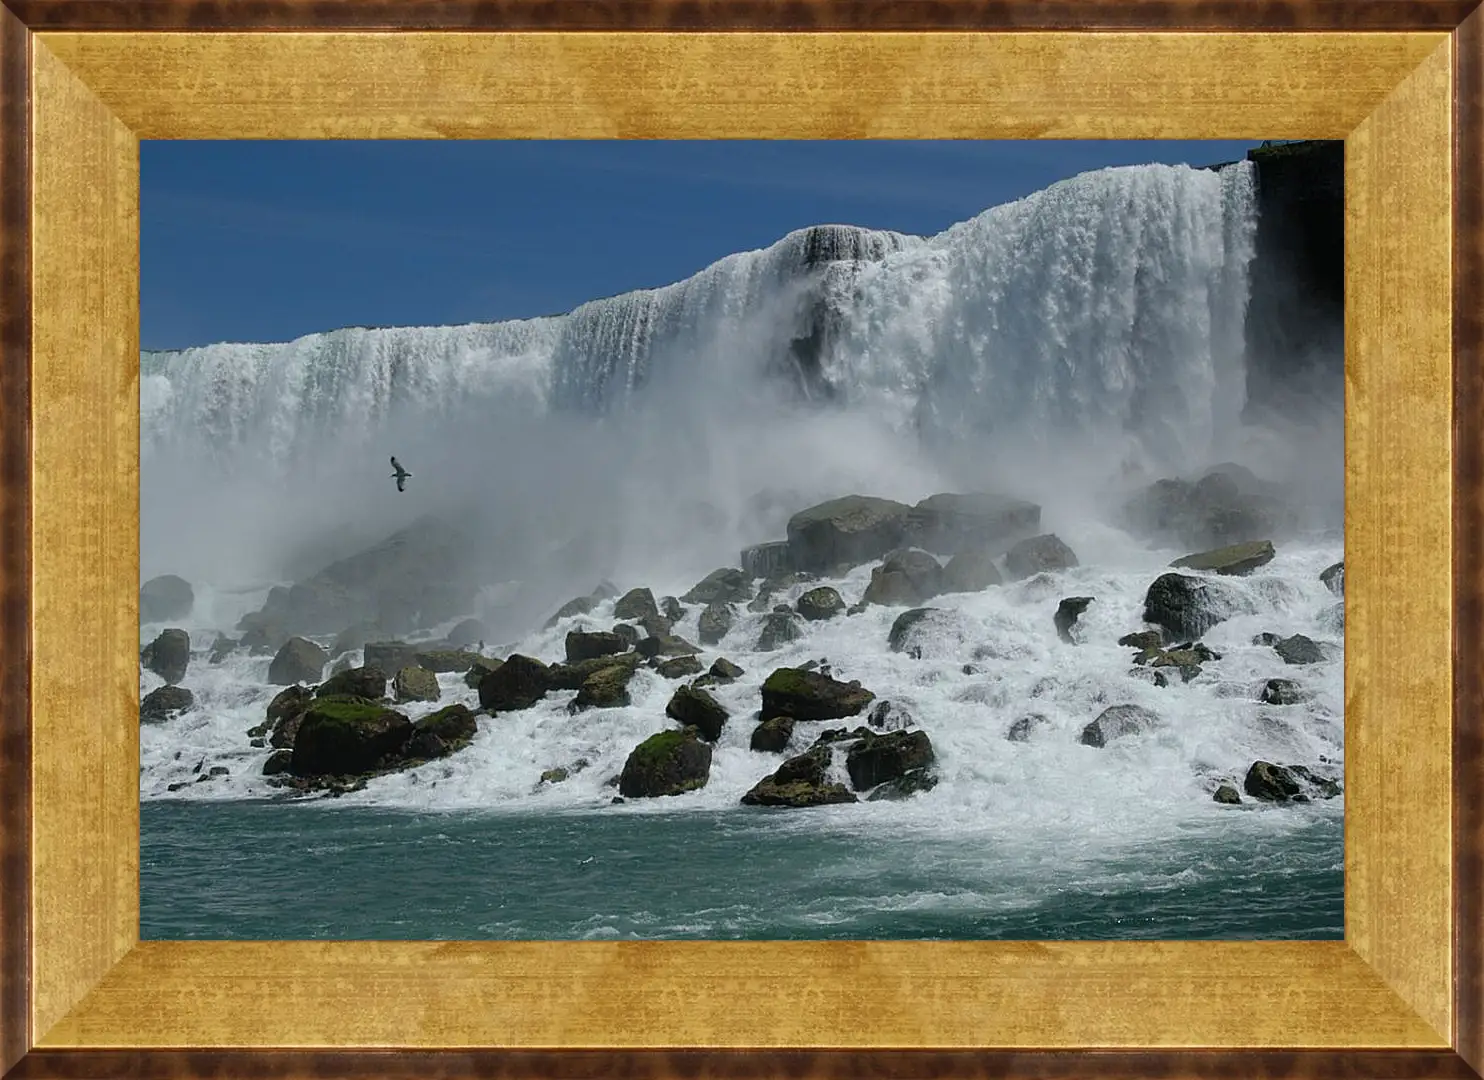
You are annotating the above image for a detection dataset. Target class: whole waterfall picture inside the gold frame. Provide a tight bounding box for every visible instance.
[139,141,1345,939]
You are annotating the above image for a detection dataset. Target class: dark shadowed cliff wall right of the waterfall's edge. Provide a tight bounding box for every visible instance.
[1247,141,1345,420]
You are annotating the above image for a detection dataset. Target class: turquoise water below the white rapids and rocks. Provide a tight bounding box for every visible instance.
[141,801,1345,941]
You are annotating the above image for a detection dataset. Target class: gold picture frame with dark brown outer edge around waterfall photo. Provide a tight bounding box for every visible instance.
[0,0,1484,1077]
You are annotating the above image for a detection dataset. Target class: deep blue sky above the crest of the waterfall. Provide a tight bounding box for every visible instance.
[139,141,1257,349]
